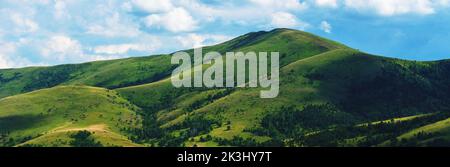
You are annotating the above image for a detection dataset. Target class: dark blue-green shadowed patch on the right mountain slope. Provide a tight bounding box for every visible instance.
[341,61,450,119]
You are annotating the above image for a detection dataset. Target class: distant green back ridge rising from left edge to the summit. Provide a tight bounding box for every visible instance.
[0,29,345,98]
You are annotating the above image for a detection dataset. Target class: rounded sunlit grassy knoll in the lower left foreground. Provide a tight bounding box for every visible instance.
[0,86,141,146]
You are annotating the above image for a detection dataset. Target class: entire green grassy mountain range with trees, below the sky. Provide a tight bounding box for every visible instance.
[0,29,450,146]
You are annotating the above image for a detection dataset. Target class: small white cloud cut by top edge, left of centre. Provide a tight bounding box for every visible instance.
[131,0,174,13]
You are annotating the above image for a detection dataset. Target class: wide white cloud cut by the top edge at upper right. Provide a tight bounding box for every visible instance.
[345,0,436,16]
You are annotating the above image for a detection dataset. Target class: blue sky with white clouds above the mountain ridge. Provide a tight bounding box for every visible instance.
[0,0,450,69]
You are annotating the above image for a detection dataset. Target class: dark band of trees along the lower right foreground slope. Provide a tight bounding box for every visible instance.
[298,112,450,147]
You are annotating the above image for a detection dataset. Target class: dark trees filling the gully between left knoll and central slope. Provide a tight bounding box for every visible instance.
[125,88,233,146]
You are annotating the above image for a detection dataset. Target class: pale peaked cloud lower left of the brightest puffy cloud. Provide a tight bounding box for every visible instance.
[87,12,140,37]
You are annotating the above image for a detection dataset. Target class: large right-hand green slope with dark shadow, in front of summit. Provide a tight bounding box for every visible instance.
[155,49,450,146]
